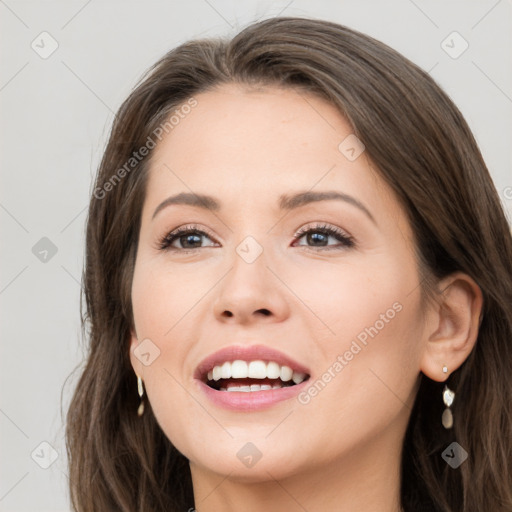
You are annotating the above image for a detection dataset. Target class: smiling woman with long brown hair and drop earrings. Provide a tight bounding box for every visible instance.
[67,17,512,512]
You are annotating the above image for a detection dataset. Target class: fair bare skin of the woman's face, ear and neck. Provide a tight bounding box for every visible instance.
[130,84,482,512]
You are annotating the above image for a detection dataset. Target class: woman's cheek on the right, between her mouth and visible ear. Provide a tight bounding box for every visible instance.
[289,252,422,408]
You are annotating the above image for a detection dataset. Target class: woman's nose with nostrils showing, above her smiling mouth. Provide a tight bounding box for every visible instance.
[214,244,289,325]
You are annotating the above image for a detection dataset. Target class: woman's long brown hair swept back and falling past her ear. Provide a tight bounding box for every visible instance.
[66,17,512,512]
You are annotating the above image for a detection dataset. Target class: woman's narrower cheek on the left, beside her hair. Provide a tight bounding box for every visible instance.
[132,262,204,456]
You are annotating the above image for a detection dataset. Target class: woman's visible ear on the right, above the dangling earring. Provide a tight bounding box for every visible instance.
[420,272,483,382]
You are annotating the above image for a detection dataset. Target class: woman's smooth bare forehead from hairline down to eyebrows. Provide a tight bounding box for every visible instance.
[147,84,404,227]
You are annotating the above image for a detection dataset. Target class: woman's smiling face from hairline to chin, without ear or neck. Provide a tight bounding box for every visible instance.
[131,85,425,481]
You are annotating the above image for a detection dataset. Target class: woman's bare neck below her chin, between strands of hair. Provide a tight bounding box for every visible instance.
[190,424,403,512]
